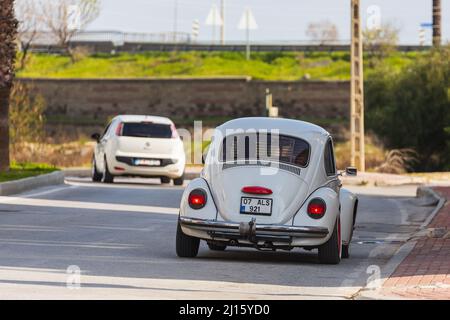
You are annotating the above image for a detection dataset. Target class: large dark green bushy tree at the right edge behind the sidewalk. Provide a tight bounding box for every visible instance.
[366,46,450,171]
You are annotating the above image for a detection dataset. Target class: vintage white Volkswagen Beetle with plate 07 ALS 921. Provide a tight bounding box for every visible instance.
[176,118,358,264]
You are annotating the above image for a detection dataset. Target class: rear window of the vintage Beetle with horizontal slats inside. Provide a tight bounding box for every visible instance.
[221,134,311,167]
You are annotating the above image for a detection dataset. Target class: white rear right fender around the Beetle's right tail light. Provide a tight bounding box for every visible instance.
[293,187,339,242]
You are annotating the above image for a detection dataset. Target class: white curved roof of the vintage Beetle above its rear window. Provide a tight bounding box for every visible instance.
[217,117,330,138]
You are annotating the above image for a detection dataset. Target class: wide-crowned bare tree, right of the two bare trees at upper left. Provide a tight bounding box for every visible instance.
[41,0,100,62]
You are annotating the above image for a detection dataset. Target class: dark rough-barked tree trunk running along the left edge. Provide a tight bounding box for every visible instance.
[0,0,17,170]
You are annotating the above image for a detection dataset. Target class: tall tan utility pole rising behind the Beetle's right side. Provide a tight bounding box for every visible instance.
[350,0,366,172]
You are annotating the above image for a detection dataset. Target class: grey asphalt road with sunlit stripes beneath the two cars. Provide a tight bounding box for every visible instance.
[0,178,432,299]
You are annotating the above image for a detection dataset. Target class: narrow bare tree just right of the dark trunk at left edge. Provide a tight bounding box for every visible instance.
[15,0,43,70]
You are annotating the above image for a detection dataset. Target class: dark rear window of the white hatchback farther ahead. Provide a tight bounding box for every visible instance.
[122,122,172,139]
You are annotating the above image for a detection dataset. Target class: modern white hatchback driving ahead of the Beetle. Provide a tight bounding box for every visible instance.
[92,115,186,185]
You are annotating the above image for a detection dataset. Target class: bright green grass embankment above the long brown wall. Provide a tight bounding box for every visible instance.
[17,52,420,80]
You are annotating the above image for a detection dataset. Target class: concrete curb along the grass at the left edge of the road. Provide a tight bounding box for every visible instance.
[0,171,64,196]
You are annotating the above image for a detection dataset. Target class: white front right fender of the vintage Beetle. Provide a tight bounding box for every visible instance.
[339,188,358,244]
